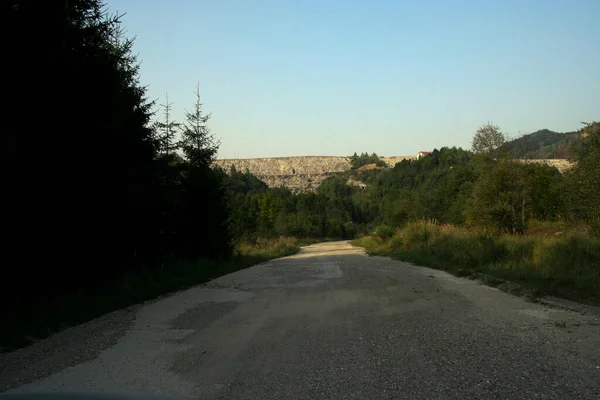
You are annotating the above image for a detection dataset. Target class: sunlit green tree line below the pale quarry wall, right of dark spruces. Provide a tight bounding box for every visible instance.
[227,122,600,238]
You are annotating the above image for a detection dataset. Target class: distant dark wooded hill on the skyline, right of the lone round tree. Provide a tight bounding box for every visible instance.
[503,129,579,160]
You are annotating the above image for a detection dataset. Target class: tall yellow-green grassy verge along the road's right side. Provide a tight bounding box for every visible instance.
[353,222,600,304]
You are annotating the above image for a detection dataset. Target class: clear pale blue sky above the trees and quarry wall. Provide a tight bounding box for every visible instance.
[107,0,600,158]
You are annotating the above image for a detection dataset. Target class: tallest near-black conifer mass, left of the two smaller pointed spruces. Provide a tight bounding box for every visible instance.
[0,0,159,307]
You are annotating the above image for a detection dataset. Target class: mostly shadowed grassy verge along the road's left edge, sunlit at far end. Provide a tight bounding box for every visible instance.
[0,238,300,352]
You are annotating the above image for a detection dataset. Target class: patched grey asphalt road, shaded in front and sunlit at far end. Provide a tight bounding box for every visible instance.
[0,242,600,400]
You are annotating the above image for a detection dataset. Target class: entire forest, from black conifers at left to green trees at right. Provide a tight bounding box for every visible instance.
[0,0,600,350]
